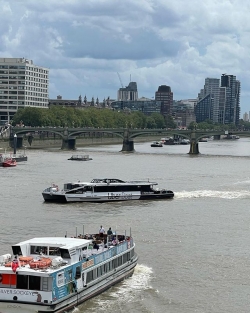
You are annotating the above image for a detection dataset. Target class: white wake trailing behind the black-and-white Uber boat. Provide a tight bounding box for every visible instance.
[175,190,250,199]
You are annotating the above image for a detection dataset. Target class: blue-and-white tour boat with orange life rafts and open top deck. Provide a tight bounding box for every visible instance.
[0,229,138,313]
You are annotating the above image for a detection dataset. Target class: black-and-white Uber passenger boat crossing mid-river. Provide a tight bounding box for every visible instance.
[42,178,174,202]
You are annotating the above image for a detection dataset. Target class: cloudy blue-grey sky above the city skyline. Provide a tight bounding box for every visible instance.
[0,0,250,116]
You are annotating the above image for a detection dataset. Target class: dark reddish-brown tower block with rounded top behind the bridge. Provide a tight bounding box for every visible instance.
[155,85,173,116]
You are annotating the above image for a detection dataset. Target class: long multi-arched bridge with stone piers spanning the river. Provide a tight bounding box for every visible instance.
[9,127,250,154]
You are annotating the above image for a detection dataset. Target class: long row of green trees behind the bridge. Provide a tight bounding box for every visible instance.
[12,106,176,129]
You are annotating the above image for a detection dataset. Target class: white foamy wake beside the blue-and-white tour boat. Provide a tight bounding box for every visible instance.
[80,264,153,312]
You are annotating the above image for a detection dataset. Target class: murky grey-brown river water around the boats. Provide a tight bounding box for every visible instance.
[0,138,250,313]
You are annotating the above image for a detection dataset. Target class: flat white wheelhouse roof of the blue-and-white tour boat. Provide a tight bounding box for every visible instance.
[13,237,92,249]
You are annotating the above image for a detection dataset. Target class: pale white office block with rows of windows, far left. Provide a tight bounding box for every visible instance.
[0,58,49,125]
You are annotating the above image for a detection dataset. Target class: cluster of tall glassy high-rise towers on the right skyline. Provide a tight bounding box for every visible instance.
[195,74,240,125]
